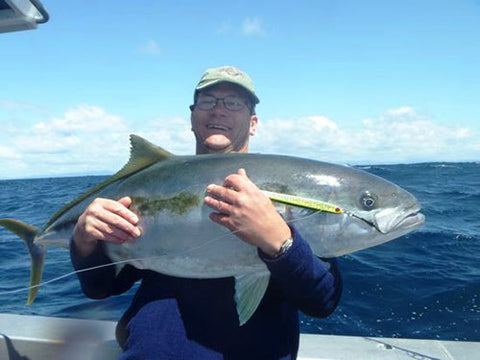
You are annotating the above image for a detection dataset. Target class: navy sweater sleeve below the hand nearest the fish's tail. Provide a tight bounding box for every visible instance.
[70,238,141,299]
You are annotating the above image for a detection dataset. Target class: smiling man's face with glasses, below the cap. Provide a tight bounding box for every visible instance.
[191,83,258,154]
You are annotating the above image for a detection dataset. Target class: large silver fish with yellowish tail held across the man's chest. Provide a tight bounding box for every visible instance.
[0,135,424,324]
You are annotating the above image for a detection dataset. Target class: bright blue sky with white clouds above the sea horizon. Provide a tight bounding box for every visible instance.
[0,0,480,179]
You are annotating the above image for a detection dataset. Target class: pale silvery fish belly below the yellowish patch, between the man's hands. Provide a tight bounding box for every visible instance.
[107,211,266,279]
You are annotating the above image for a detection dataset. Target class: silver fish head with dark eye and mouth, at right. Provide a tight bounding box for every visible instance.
[299,168,425,257]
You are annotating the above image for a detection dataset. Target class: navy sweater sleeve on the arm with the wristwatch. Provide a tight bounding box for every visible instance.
[259,228,342,317]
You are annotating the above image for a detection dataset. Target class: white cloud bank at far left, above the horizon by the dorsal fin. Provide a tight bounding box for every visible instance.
[0,105,128,178]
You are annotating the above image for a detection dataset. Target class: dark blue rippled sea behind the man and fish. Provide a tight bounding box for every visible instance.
[0,163,480,341]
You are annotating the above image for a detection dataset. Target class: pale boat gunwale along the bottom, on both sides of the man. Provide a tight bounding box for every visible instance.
[0,313,480,360]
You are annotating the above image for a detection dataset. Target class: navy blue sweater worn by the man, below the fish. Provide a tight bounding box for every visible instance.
[71,229,342,360]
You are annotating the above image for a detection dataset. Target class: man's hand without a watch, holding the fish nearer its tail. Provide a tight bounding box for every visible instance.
[73,196,142,257]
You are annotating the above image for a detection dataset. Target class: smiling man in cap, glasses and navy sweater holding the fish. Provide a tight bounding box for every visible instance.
[71,67,342,359]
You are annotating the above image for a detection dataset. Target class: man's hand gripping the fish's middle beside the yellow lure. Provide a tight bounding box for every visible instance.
[205,169,291,256]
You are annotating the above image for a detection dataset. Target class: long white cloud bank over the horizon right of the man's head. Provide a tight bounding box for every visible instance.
[251,107,480,163]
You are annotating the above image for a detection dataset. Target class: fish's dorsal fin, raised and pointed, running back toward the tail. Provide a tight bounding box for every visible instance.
[45,134,174,228]
